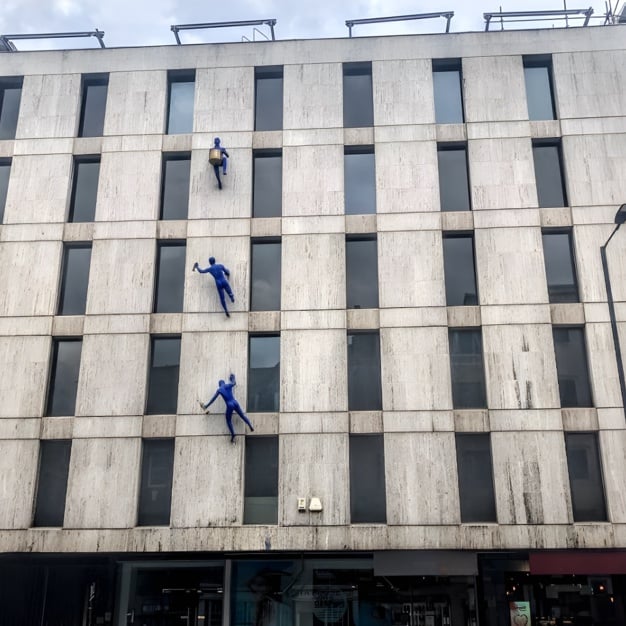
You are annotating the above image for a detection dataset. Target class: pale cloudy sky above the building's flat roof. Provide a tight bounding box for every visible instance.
[0,0,623,50]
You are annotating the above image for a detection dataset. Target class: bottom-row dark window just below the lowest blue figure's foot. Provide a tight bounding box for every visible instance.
[243,437,278,524]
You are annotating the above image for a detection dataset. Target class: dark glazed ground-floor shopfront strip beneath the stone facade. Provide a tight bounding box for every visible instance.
[0,551,626,626]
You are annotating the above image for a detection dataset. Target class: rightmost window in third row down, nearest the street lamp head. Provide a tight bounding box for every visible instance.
[542,230,578,302]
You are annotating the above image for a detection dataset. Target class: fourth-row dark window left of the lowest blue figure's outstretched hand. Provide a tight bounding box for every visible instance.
[146,336,180,415]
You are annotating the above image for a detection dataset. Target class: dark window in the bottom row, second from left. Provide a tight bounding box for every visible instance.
[137,439,174,526]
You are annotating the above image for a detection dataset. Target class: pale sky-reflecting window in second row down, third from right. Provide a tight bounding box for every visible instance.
[343,146,376,215]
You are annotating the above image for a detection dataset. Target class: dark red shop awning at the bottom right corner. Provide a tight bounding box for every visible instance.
[529,550,626,575]
